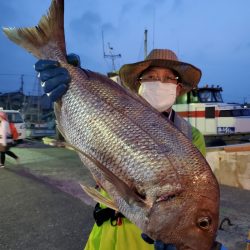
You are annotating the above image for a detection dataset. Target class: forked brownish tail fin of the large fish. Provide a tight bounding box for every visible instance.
[3,0,66,60]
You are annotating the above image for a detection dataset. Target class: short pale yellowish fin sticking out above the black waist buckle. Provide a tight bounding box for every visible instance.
[80,184,118,211]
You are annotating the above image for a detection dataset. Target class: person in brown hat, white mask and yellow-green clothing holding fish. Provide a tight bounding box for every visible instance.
[35,49,226,250]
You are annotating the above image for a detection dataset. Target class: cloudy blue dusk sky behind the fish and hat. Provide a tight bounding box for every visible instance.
[0,0,250,103]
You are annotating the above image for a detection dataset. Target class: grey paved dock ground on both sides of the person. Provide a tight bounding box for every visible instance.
[0,143,250,250]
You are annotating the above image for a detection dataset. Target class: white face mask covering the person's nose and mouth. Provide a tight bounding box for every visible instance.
[138,81,177,112]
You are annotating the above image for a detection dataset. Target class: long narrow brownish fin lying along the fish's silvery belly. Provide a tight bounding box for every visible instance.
[65,143,148,207]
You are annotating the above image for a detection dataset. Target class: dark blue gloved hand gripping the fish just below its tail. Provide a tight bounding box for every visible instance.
[35,54,81,102]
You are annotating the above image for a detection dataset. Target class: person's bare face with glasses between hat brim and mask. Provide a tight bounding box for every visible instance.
[140,67,182,97]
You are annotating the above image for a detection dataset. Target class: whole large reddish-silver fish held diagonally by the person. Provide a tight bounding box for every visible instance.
[4,0,219,250]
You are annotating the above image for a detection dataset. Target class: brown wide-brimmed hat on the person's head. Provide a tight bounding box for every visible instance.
[119,49,201,95]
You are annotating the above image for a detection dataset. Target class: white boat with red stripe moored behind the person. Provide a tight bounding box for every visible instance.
[173,85,250,146]
